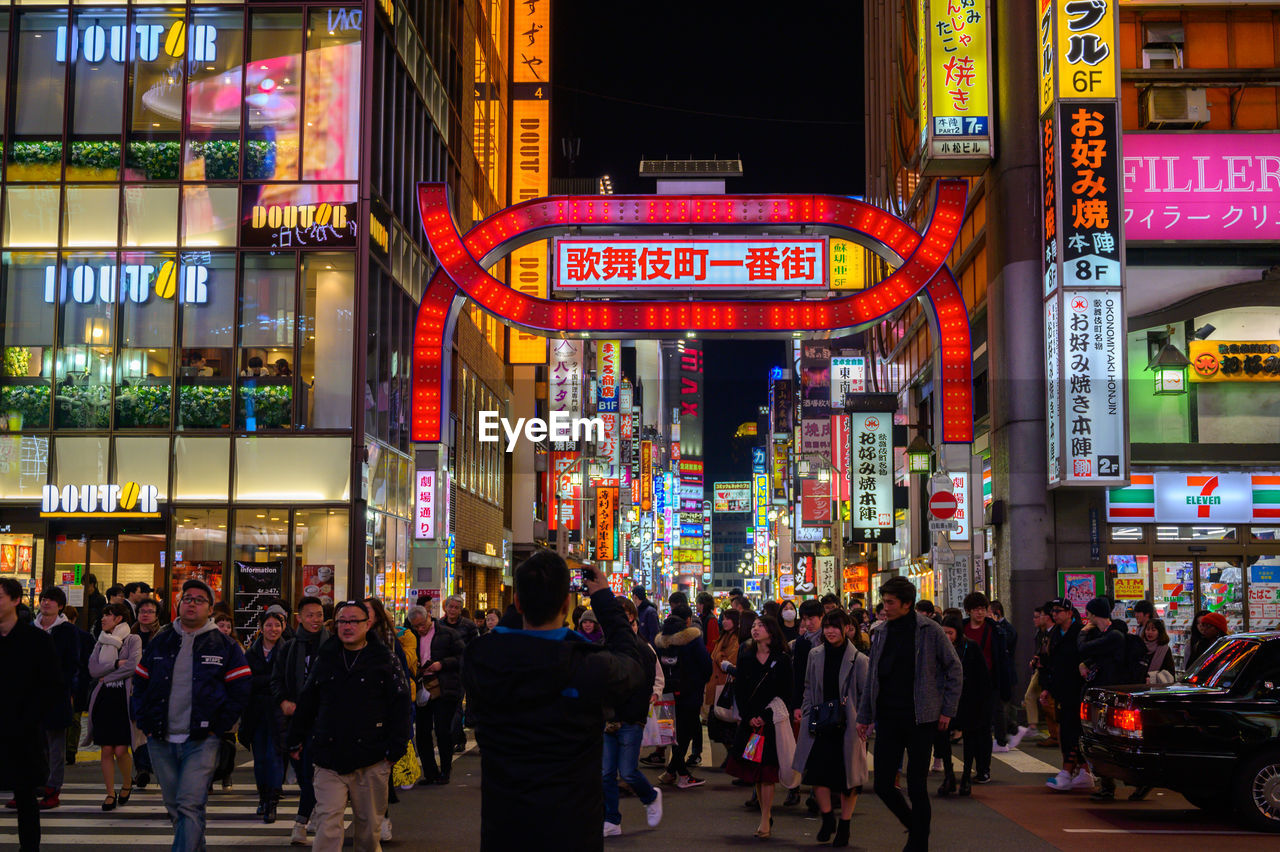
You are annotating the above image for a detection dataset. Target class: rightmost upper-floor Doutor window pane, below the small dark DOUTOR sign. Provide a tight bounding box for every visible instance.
[297,253,356,429]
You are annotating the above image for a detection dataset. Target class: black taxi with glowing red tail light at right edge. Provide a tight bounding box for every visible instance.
[1080,632,1280,832]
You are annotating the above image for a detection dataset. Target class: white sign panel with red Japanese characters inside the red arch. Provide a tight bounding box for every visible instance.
[556,237,828,290]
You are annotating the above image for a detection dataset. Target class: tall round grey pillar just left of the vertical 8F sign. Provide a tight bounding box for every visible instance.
[986,3,1056,639]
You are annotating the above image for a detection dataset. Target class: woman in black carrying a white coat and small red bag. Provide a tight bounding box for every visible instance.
[721,615,792,840]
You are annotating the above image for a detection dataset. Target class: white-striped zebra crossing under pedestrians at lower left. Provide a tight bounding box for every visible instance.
[0,765,351,849]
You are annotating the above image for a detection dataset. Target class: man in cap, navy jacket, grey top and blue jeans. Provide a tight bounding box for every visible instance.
[132,580,252,852]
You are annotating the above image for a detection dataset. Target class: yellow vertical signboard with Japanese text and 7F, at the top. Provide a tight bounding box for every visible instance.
[920,0,995,175]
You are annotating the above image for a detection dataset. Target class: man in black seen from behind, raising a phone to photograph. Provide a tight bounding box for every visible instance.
[462,550,648,852]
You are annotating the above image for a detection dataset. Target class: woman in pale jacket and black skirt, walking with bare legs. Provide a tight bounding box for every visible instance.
[88,604,142,811]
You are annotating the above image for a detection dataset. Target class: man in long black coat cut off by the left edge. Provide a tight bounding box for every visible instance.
[0,577,67,849]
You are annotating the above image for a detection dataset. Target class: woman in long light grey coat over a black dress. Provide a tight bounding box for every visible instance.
[791,609,870,846]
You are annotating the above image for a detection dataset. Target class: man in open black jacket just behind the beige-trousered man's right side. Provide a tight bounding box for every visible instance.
[401,606,471,784]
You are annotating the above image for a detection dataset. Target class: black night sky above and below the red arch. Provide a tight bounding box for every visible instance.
[552,0,865,489]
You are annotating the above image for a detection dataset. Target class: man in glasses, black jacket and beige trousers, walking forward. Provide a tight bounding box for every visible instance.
[288,600,411,852]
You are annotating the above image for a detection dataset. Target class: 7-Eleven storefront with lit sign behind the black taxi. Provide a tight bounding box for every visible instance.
[1106,469,1280,663]
